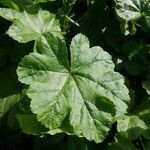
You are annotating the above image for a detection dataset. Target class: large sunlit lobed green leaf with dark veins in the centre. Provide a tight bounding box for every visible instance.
[17,34,130,142]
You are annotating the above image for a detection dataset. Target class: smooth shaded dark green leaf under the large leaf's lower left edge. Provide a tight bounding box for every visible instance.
[16,114,47,135]
